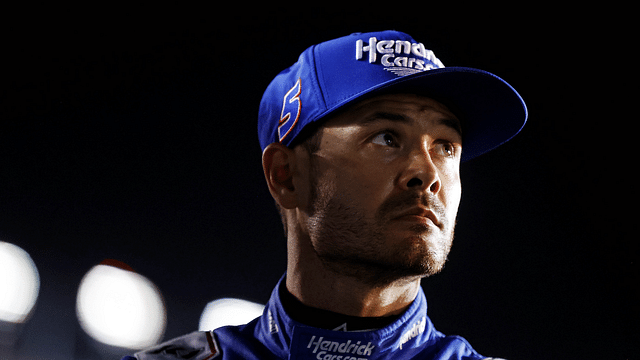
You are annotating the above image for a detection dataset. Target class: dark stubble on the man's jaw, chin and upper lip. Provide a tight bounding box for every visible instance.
[309,156,455,286]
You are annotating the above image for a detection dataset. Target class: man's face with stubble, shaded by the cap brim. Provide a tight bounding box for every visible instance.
[296,94,462,283]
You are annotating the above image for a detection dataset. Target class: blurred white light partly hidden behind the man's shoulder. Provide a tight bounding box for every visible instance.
[198,298,264,331]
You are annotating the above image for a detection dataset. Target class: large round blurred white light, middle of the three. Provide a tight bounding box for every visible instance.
[76,261,167,349]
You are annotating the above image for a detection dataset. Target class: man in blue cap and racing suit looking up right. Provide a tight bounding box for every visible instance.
[124,31,527,360]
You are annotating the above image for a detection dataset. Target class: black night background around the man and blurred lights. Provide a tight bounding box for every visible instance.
[0,3,640,359]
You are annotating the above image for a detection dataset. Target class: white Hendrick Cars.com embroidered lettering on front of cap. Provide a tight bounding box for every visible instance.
[356,37,444,76]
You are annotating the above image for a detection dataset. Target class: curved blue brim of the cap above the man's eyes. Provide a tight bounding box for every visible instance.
[323,67,527,162]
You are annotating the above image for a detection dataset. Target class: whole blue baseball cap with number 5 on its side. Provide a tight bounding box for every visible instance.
[258,31,527,161]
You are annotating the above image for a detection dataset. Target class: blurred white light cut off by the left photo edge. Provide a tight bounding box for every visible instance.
[0,241,40,324]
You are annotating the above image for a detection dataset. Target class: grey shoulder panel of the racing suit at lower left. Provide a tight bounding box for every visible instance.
[122,331,220,360]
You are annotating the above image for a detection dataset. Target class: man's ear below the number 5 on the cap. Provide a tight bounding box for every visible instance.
[262,143,297,209]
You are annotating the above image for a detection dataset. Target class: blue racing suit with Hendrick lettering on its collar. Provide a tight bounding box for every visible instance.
[122,277,498,360]
